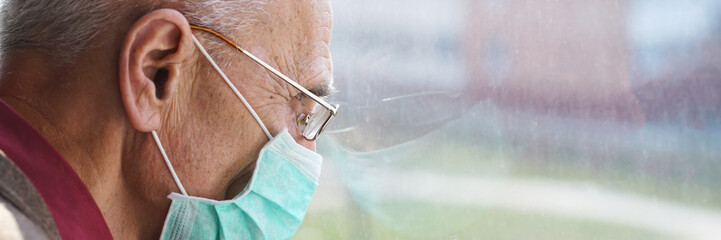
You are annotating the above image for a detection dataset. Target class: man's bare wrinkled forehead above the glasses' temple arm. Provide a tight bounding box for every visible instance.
[250,0,332,92]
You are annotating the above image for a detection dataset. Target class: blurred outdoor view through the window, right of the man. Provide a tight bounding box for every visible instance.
[294,0,721,239]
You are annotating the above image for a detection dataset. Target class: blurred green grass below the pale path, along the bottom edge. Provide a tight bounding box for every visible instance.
[293,204,669,240]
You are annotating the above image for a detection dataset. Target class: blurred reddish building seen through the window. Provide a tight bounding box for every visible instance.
[464,0,645,125]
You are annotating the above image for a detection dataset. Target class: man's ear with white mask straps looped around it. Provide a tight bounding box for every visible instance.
[119,9,193,132]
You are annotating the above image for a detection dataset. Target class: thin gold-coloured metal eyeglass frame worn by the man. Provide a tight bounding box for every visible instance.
[190,24,339,141]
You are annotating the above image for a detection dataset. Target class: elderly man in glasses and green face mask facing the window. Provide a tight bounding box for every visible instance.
[0,0,337,239]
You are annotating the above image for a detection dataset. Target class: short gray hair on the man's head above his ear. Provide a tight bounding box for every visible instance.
[0,0,265,61]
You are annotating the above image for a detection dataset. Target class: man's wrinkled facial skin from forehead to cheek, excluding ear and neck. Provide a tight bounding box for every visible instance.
[161,1,332,202]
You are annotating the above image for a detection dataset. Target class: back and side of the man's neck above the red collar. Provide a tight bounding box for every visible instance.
[0,53,166,239]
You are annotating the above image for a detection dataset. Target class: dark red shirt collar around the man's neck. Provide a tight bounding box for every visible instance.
[0,100,112,239]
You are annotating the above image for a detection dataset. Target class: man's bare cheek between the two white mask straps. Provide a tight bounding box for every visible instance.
[168,80,262,199]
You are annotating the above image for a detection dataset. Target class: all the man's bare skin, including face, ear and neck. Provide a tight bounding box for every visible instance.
[0,0,332,239]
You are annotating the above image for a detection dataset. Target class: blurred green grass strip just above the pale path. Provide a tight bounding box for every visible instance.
[396,139,721,210]
